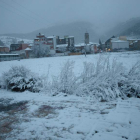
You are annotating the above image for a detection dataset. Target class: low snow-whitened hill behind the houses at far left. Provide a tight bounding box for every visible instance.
[0,36,33,48]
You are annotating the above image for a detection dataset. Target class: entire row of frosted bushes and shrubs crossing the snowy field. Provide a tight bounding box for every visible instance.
[2,52,140,101]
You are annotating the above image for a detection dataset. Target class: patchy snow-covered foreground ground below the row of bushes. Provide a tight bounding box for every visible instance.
[0,90,140,140]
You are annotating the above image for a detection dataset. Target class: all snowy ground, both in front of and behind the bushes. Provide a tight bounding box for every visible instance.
[0,52,140,140]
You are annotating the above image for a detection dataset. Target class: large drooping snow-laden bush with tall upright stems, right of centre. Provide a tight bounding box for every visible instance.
[75,56,125,101]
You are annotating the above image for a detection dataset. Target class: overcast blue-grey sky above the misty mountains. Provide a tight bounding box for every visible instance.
[0,0,140,34]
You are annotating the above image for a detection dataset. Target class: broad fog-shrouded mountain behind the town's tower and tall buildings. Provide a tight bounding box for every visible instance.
[0,21,98,43]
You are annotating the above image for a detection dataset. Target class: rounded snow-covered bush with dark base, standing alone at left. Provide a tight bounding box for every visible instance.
[3,66,42,92]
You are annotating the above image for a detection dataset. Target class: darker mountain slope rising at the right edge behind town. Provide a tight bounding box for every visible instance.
[106,18,140,37]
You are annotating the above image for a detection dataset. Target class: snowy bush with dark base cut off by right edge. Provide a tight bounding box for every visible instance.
[119,62,140,98]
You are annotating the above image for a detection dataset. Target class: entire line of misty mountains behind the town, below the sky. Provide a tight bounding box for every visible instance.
[0,17,140,43]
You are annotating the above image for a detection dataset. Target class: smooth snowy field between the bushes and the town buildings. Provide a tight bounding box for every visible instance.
[0,51,140,78]
